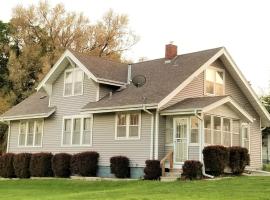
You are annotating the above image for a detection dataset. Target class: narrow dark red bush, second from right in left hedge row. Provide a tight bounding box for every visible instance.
[52,153,71,178]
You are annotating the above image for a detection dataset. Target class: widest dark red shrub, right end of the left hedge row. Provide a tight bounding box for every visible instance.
[70,151,99,176]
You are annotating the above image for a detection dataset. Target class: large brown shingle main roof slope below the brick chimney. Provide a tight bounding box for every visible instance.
[83,48,221,109]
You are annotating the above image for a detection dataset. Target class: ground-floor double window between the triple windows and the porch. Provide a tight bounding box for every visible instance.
[115,113,141,139]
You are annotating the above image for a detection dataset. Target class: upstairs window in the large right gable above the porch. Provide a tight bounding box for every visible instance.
[205,68,224,95]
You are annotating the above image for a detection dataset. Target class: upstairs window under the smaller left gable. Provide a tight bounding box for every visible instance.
[64,68,83,96]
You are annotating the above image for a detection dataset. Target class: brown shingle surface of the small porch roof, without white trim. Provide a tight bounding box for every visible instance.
[163,96,227,111]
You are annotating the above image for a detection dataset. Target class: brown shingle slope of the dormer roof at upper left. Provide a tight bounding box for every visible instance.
[69,50,128,83]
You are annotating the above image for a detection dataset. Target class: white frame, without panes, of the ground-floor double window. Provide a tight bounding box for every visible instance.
[114,112,142,140]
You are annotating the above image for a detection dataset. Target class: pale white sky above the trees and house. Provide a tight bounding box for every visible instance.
[0,0,270,95]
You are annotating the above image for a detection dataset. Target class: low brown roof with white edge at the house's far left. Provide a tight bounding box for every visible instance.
[1,92,56,120]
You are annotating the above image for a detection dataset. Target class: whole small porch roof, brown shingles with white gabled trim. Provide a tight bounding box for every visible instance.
[161,96,253,122]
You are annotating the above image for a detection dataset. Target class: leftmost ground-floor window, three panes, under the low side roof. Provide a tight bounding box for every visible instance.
[18,120,44,147]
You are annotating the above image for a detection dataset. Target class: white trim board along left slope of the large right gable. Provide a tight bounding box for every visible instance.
[158,48,224,108]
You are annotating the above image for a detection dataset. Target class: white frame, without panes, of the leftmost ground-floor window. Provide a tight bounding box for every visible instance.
[17,119,44,148]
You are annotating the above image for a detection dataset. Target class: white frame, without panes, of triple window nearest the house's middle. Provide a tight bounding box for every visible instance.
[61,115,94,147]
